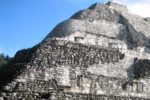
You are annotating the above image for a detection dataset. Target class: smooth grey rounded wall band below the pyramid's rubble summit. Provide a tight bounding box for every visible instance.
[47,19,125,38]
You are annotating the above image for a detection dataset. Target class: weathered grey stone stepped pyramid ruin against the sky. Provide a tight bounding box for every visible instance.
[0,2,150,100]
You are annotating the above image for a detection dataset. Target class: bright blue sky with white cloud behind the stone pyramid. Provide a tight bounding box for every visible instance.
[0,0,150,56]
